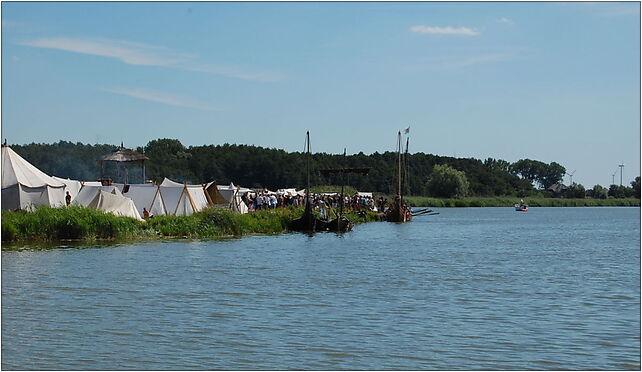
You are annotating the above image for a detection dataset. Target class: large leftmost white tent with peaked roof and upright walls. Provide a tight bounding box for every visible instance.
[2,146,65,210]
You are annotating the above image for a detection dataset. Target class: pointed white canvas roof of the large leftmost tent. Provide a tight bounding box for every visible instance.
[2,146,65,189]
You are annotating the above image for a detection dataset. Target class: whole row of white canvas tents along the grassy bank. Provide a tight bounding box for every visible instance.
[2,146,252,220]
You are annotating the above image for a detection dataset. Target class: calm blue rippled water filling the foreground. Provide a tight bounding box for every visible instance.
[2,208,640,370]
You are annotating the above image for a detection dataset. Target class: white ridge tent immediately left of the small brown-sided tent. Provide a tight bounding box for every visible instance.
[159,178,210,216]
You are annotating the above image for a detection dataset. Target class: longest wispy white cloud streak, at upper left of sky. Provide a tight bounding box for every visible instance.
[19,37,283,82]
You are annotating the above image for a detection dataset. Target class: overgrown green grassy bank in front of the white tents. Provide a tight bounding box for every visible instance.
[2,206,376,242]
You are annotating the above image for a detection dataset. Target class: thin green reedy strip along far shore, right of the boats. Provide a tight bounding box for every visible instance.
[404,196,640,208]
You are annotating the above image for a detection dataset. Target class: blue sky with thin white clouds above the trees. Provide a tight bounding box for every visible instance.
[1,2,640,188]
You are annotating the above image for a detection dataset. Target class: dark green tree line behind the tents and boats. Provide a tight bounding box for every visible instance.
[7,138,639,197]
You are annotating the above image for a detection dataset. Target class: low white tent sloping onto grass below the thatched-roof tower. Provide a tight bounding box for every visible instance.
[72,186,143,221]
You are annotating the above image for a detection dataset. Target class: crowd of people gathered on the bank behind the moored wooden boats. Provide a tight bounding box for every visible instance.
[242,192,380,217]
